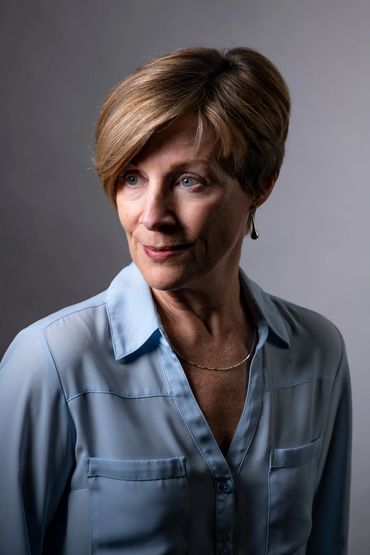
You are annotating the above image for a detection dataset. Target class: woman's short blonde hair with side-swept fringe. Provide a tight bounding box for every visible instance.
[95,48,290,203]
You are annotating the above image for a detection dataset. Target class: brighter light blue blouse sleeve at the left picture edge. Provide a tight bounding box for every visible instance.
[0,329,75,555]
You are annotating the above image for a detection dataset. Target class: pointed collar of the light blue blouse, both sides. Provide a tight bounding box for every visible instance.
[107,263,289,360]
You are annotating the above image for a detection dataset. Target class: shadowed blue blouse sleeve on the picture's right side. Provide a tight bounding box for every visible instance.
[307,334,352,555]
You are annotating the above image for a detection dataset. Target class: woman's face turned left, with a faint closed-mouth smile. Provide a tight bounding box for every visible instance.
[116,118,252,291]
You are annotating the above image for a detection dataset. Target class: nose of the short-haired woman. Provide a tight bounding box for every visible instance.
[139,187,176,231]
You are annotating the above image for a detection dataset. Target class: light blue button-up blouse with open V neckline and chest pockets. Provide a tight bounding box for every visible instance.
[0,264,351,555]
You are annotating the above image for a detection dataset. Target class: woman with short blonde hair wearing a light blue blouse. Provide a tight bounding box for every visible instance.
[0,48,350,555]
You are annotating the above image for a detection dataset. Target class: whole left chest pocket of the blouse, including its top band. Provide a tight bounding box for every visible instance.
[87,457,188,555]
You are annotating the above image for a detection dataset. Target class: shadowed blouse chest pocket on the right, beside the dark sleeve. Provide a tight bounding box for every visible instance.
[267,437,321,555]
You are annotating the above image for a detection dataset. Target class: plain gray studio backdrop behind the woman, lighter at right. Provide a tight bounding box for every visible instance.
[0,0,370,555]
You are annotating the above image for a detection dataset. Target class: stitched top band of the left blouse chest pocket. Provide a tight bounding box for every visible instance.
[87,457,185,480]
